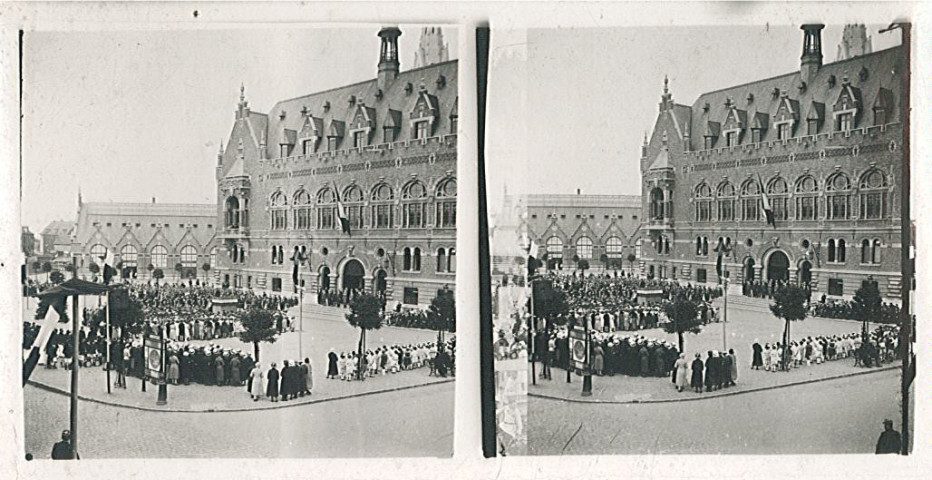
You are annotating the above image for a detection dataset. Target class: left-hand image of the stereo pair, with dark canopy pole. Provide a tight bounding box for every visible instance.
[21,24,459,460]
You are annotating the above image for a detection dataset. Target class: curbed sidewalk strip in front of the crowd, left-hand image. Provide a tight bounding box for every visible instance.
[29,365,454,412]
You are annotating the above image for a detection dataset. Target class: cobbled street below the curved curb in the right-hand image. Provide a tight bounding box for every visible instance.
[528,371,902,455]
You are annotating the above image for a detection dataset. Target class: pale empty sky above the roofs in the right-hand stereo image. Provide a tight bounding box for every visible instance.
[487,25,900,211]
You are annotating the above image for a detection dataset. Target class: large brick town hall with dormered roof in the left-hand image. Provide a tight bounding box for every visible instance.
[216,27,457,305]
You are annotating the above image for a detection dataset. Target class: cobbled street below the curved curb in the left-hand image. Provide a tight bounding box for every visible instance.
[25,383,454,459]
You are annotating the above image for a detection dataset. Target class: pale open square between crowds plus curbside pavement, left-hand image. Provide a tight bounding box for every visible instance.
[31,304,450,411]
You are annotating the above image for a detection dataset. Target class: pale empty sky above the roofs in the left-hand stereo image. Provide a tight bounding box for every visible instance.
[22,25,458,233]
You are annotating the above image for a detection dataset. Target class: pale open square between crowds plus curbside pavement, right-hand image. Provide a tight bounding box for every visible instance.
[528,305,900,402]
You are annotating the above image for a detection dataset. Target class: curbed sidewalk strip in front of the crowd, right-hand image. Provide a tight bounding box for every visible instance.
[528,358,901,403]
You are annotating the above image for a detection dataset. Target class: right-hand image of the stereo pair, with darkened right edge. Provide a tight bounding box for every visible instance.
[487,22,915,455]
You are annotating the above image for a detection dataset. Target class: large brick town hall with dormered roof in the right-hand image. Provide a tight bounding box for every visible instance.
[640,25,908,300]
